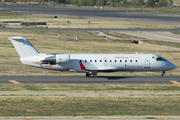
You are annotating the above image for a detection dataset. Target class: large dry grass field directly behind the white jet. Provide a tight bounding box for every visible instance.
[0,31,180,76]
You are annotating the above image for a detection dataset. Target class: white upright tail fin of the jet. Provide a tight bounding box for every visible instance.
[8,36,39,58]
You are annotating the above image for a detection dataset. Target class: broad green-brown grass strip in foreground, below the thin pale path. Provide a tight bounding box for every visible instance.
[0,95,180,117]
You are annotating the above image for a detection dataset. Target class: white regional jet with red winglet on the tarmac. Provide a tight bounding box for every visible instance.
[8,37,177,78]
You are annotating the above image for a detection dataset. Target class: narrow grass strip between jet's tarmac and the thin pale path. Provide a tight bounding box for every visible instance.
[0,84,180,94]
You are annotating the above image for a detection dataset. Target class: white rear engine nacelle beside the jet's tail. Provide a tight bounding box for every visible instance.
[43,54,70,64]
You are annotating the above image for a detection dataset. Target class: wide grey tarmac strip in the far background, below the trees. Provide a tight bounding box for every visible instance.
[0,5,180,25]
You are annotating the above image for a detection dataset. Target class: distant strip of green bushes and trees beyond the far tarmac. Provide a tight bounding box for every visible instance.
[4,0,173,7]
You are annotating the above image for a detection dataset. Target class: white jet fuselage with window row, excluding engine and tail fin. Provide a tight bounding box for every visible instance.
[21,54,176,72]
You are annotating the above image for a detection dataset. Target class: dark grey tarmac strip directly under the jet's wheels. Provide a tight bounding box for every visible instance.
[0,76,180,84]
